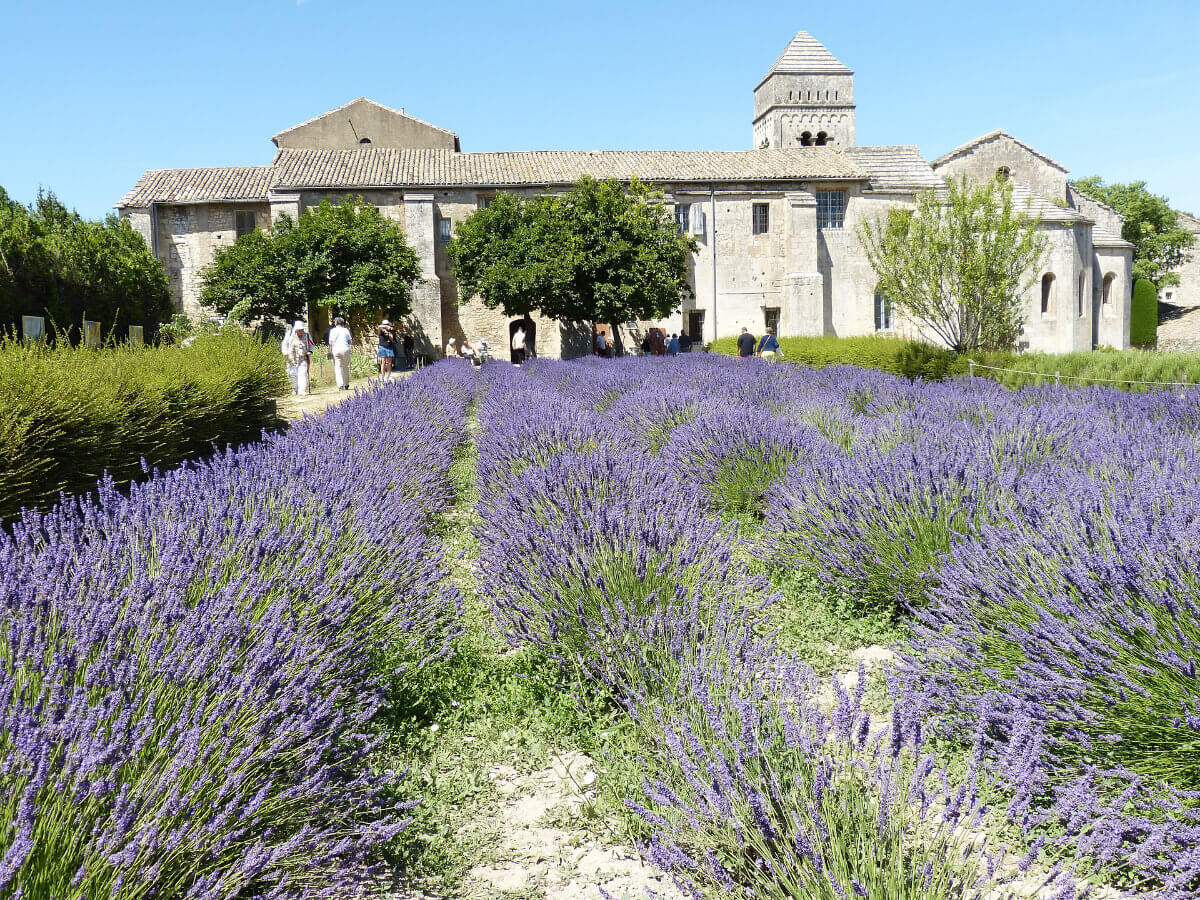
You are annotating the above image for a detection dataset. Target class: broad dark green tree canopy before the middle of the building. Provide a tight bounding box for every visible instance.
[448,178,696,323]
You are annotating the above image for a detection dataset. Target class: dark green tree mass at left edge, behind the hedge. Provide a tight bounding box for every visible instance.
[0,187,172,338]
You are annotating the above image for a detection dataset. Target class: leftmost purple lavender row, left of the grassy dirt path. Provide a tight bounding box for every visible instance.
[0,370,470,899]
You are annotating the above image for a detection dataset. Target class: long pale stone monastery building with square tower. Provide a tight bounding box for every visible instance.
[118,31,1133,356]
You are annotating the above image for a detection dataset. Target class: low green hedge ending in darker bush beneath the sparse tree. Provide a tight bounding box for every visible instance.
[709,336,966,379]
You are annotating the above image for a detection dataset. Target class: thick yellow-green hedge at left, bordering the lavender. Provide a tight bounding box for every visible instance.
[0,332,288,518]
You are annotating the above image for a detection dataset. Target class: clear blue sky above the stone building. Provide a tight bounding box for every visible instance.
[0,0,1200,216]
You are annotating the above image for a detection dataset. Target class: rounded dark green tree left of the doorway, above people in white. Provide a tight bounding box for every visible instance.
[200,198,421,323]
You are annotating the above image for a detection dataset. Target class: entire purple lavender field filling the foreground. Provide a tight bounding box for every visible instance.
[0,354,1200,900]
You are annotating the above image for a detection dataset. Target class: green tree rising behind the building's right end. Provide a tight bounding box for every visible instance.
[1072,175,1195,287]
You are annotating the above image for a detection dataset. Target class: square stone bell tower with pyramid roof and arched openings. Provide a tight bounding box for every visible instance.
[754,31,854,150]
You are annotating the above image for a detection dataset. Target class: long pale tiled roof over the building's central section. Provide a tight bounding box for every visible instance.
[272,148,866,190]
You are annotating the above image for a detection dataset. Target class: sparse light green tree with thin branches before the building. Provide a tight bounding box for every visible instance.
[858,179,1046,350]
